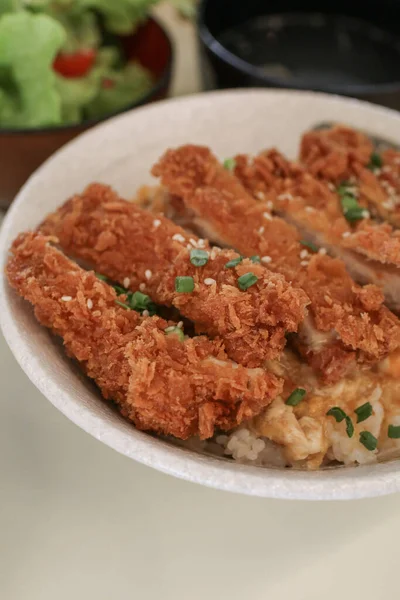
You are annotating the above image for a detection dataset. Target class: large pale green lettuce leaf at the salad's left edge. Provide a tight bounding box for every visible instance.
[0,11,65,127]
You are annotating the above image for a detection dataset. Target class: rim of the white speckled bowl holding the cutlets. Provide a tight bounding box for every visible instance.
[0,88,400,500]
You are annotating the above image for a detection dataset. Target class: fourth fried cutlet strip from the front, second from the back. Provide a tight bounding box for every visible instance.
[231,150,400,311]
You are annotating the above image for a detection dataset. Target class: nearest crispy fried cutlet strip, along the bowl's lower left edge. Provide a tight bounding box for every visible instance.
[6,233,282,439]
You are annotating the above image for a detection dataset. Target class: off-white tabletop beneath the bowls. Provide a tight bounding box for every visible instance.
[0,5,400,600]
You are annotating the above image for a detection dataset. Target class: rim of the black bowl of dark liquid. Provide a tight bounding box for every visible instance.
[197,0,400,97]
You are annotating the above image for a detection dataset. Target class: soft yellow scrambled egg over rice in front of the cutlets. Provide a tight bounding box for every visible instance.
[251,353,400,469]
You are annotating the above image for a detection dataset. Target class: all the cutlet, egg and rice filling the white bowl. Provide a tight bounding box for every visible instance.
[7,128,400,469]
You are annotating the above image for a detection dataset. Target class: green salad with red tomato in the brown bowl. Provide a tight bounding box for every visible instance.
[0,0,164,128]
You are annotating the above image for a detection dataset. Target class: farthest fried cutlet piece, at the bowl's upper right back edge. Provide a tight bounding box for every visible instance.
[300,126,400,227]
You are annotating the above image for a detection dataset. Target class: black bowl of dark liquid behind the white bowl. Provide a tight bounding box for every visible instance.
[198,0,400,109]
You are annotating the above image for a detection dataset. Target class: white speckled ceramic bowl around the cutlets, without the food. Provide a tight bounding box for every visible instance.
[0,89,400,500]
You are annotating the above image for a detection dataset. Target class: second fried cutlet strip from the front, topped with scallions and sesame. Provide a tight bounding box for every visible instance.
[41,184,308,367]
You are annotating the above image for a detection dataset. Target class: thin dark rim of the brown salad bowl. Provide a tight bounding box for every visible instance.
[0,15,175,137]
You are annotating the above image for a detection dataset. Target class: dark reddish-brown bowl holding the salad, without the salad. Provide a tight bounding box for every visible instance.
[0,18,173,209]
